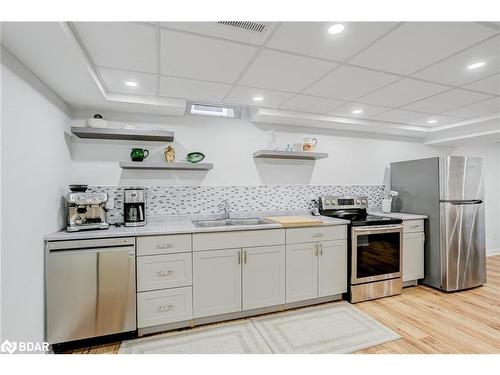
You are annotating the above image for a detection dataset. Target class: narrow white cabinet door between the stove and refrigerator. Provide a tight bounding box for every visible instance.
[403,232,425,281]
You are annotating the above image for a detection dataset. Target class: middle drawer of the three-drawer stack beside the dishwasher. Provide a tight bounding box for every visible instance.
[137,253,192,292]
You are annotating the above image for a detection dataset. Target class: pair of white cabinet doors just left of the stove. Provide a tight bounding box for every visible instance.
[286,240,347,303]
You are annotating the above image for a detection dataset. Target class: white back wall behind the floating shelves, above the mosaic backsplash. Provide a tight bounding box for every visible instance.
[69,113,438,186]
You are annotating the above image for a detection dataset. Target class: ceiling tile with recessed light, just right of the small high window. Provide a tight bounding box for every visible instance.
[224,86,293,107]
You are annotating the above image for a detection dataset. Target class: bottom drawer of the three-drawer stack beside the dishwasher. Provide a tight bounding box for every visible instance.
[137,287,193,328]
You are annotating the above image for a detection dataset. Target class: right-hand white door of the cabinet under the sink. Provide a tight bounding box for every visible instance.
[242,246,285,310]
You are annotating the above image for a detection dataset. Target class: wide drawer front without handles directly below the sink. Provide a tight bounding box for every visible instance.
[193,229,285,251]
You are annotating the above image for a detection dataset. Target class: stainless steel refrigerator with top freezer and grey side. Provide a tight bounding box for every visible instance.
[390,156,486,291]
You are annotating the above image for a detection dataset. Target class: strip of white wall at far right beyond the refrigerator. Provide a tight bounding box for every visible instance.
[454,143,500,254]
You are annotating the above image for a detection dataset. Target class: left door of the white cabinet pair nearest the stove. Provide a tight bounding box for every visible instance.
[286,243,318,303]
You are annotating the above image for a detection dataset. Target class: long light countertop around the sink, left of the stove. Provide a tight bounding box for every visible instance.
[44,215,349,241]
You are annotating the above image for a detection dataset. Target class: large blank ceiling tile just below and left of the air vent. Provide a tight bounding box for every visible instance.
[160,30,257,83]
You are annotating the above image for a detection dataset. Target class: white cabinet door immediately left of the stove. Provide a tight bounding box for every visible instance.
[318,240,347,297]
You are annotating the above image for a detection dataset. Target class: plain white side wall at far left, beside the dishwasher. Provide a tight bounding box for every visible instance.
[0,51,71,341]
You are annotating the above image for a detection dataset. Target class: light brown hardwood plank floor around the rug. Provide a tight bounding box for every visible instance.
[66,255,500,354]
